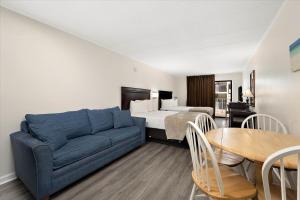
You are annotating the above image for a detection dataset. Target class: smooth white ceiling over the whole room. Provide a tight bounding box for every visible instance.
[0,0,283,75]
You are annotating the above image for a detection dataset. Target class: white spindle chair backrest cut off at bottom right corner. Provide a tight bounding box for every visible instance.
[262,146,300,200]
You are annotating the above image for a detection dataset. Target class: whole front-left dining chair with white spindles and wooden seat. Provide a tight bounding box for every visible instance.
[186,122,257,200]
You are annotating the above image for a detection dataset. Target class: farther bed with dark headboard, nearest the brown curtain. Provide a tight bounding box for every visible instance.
[158,90,214,116]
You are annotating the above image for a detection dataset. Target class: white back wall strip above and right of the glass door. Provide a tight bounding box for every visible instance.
[215,72,243,102]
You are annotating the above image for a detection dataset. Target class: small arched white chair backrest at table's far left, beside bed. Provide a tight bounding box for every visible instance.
[195,113,217,134]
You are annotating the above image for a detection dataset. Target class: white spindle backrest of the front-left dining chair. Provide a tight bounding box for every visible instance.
[186,122,224,196]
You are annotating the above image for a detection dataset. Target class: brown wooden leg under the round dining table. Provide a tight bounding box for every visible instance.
[255,162,273,200]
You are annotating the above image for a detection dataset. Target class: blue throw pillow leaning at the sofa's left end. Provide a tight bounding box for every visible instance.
[29,122,67,151]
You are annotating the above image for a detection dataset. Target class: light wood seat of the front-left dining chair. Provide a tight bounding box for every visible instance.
[192,166,257,199]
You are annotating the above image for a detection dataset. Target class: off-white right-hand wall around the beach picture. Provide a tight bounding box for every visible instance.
[244,0,300,136]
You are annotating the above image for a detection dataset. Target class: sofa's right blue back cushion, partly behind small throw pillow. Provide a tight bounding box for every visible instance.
[88,107,120,134]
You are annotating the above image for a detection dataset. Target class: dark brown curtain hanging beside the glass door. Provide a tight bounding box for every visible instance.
[187,75,215,108]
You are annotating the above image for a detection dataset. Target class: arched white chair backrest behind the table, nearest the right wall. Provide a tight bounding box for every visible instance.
[242,114,287,134]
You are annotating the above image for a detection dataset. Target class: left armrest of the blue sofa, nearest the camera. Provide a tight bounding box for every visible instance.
[10,132,53,199]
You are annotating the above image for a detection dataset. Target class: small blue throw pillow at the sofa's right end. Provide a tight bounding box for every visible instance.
[113,110,133,128]
